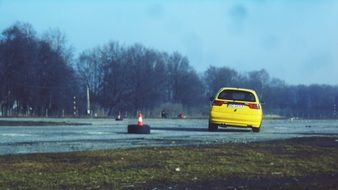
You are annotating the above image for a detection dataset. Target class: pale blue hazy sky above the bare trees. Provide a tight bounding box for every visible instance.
[0,0,338,85]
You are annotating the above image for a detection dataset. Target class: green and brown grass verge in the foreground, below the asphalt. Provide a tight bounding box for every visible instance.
[0,138,338,189]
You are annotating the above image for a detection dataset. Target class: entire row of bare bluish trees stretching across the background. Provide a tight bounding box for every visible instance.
[0,23,338,118]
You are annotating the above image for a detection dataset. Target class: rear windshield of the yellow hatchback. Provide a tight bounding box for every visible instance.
[218,90,256,102]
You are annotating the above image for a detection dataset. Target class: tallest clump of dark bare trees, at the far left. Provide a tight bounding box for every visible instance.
[0,23,78,116]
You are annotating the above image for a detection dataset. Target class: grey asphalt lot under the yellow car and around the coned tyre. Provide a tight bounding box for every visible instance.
[0,118,338,155]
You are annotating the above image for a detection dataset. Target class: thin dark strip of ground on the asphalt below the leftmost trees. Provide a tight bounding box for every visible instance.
[0,120,91,126]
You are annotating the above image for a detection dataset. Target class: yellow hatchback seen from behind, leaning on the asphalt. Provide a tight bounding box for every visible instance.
[209,88,263,132]
